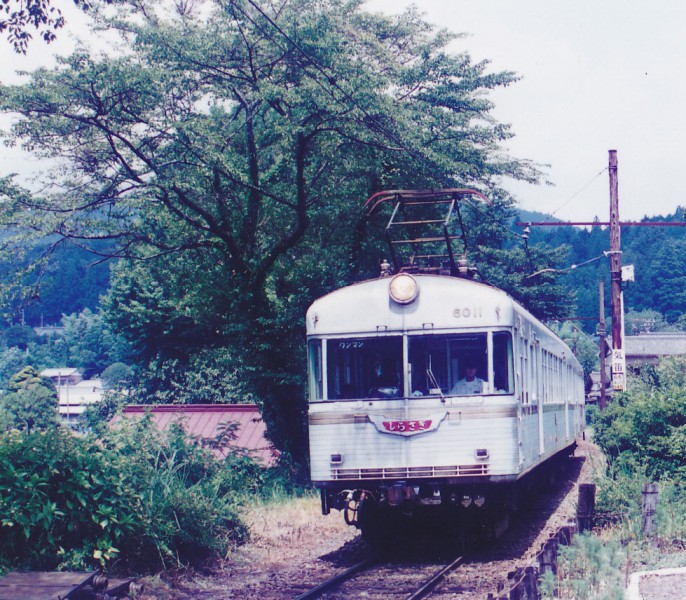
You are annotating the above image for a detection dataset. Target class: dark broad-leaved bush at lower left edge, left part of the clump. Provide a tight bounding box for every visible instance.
[0,428,138,570]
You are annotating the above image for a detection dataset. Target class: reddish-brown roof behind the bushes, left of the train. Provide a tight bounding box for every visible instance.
[123,404,278,466]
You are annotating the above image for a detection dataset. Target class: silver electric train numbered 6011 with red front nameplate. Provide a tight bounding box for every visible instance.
[307,196,585,539]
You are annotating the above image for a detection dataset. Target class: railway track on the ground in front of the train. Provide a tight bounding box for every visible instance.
[297,556,465,600]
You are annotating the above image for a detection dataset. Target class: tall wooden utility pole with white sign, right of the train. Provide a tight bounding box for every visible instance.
[608,150,626,391]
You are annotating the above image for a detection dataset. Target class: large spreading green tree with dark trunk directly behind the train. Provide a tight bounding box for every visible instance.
[0,0,564,452]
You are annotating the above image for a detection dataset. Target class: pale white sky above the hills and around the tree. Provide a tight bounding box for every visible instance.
[0,0,686,221]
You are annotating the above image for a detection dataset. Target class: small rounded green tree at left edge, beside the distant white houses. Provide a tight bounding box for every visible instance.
[0,366,58,431]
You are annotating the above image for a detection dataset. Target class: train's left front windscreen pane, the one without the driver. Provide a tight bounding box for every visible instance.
[326,336,403,400]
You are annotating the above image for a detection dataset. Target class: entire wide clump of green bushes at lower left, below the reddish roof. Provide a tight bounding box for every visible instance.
[0,418,269,571]
